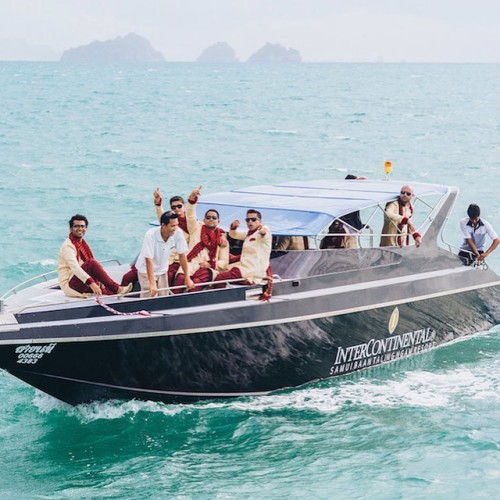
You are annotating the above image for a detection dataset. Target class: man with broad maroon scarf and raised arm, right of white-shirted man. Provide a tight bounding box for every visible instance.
[173,186,229,293]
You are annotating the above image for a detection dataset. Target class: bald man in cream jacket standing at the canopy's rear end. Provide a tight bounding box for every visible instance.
[380,186,422,247]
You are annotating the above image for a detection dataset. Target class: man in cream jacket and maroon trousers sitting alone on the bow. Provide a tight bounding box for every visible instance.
[57,214,132,297]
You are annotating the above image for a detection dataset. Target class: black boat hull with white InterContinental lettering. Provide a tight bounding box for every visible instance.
[0,286,500,404]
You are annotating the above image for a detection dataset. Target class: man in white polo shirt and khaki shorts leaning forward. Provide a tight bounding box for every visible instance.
[136,210,193,297]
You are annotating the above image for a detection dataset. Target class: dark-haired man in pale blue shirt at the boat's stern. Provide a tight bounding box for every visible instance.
[458,203,500,266]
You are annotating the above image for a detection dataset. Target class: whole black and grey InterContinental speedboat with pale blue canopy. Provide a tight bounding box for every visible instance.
[0,180,500,404]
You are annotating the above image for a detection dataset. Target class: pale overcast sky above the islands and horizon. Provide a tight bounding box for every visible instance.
[0,0,500,62]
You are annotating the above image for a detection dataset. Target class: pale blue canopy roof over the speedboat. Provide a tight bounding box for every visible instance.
[197,180,450,236]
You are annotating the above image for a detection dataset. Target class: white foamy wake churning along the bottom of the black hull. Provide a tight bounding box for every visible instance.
[34,328,500,423]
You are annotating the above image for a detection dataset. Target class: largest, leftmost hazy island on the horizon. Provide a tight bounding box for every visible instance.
[61,33,165,63]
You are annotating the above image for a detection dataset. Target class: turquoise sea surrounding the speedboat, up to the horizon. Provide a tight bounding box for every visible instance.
[0,63,500,499]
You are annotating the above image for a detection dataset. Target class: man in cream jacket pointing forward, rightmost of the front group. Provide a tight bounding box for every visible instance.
[214,208,272,288]
